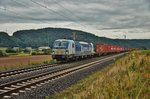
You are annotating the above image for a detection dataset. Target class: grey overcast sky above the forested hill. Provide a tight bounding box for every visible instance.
[0,0,150,39]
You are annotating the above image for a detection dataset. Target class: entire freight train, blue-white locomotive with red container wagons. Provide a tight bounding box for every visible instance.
[52,39,134,61]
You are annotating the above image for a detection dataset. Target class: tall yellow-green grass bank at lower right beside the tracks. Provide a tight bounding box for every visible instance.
[51,51,150,99]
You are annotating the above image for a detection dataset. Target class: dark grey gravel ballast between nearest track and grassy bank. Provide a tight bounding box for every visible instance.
[13,60,114,99]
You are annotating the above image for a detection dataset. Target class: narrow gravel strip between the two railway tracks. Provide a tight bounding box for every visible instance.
[0,55,112,85]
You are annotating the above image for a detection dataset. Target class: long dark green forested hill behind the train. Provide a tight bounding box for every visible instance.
[0,28,150,48]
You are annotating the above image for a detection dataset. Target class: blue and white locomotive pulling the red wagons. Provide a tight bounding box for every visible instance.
[52,39,94,61]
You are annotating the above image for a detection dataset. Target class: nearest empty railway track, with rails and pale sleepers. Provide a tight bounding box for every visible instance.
[0,54,123,99]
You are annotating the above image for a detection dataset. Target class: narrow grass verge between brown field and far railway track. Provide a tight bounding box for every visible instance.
[0,60,56,72]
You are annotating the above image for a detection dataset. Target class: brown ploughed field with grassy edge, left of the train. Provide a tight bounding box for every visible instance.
[0,55,52,71]
